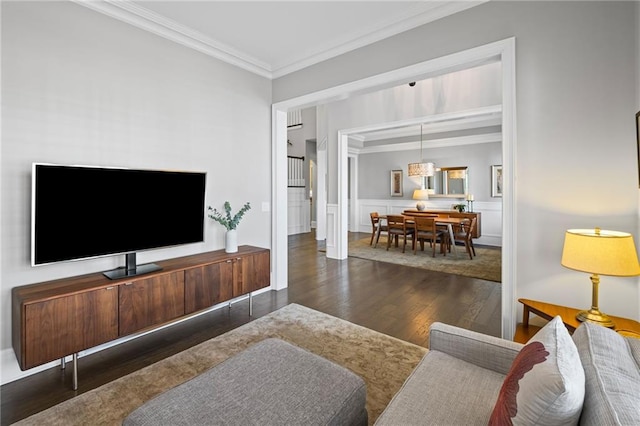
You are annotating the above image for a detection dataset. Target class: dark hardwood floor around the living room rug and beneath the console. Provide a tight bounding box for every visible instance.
[0,233,501,425]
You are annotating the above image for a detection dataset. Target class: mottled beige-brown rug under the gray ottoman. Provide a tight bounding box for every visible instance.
[17,304,427,426]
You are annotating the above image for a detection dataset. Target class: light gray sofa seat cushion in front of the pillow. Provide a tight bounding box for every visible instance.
[376,351,505,426]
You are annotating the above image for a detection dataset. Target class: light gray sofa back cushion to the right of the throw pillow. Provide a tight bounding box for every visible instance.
[573,323,640,426]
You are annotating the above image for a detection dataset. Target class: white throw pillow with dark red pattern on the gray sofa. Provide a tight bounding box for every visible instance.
[489,316,585,426]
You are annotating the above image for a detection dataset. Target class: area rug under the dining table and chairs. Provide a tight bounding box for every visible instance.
[349,236,502,282]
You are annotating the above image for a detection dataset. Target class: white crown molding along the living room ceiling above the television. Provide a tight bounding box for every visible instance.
[71,0,488,79]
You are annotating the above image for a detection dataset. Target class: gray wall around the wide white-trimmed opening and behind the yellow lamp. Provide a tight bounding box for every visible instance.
[273,2,640,319]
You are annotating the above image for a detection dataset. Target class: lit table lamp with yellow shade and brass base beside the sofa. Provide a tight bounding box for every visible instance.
[561,228,640,327]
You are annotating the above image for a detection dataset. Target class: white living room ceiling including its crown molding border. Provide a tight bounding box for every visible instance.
[74,0,486,78]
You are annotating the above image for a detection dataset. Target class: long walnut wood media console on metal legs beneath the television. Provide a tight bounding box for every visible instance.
[11,246,271,390]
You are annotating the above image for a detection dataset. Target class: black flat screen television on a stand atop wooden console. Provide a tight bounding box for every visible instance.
[31,163,206,279]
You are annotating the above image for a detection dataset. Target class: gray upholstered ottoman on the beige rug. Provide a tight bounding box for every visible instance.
[123,339,367,426]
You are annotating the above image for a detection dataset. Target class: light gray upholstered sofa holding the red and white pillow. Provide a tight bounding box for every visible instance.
[376,317,640,426]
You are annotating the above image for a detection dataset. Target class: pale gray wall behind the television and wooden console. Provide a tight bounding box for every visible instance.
[0,2,271,383]
